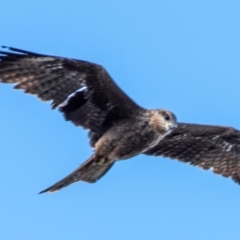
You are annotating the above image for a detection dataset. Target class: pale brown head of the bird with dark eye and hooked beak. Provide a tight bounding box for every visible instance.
[150,109,177,136]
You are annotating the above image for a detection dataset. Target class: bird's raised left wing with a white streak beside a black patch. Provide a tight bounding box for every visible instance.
[0,48,142,145]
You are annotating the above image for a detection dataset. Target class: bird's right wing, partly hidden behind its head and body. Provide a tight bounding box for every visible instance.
[145,123,240,184]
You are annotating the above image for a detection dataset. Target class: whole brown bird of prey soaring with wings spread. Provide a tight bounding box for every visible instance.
[0,48,240,193]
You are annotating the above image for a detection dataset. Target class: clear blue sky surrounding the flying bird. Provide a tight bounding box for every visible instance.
[0,0,240,240]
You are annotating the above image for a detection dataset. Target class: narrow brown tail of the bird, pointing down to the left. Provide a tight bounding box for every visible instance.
[39,154,114,194]
